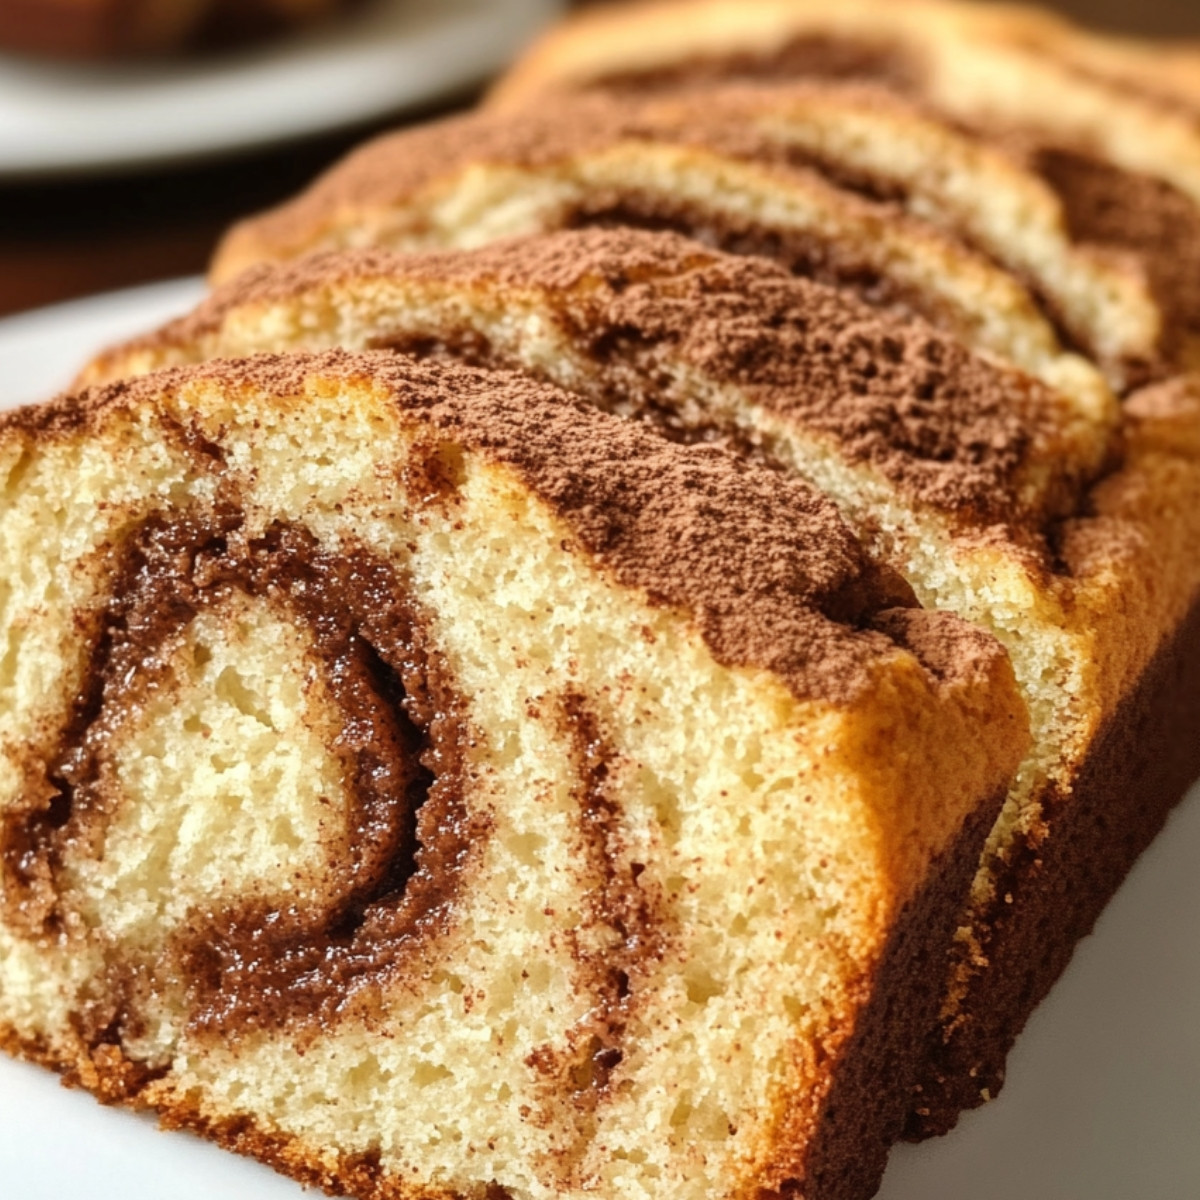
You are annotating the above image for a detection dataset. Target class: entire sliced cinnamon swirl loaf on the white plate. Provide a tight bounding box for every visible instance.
[0,0,1200,1200]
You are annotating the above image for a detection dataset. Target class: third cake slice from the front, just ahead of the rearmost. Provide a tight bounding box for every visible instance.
[212,92,1123,406]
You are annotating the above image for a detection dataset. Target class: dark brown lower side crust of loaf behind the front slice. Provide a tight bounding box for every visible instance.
[907,595,1200,1140]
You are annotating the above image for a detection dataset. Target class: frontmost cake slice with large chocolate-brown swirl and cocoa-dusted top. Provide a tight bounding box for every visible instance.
[0,353,1027,1200]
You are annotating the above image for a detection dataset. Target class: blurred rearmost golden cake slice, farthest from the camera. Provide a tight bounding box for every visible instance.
[493,0,1200,381]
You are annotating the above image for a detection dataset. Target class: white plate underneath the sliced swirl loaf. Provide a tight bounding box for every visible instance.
[0,280,1200,1200]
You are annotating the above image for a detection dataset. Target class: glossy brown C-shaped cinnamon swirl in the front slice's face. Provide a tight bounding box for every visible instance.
[2,509,485,1034]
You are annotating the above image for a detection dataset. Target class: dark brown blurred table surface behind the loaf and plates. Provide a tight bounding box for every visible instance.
[0,0,1200,314]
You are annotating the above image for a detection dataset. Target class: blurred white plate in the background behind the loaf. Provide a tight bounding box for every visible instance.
[0,0,560,179]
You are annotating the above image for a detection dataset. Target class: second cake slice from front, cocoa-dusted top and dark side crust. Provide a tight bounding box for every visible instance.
[90,230,1200,1132]
